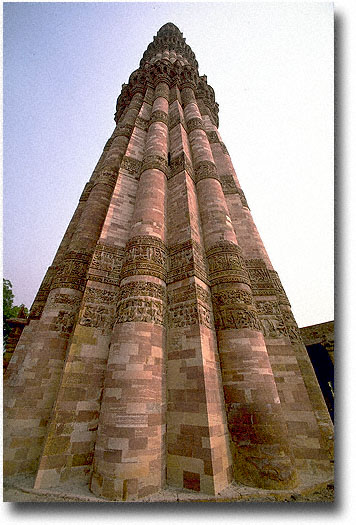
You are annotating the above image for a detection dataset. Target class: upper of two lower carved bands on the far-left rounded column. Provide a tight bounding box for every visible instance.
[51,252,90,291]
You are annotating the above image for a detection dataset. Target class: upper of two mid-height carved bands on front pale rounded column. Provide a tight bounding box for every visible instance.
[121,235,168,281]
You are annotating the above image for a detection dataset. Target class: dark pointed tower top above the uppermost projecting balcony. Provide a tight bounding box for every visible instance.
[140,22,198,72]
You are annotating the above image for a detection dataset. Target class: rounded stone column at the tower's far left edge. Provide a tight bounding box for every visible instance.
[4,93,138,478]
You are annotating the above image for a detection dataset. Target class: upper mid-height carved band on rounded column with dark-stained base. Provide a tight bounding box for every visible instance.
[206,241,249,286]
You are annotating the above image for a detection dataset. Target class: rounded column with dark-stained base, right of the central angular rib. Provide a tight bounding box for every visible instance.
[182,87,296,488]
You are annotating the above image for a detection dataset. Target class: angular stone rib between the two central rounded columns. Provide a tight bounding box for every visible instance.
[167,88,232,494]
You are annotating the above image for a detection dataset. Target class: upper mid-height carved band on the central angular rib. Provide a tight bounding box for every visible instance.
[167,240,208,283]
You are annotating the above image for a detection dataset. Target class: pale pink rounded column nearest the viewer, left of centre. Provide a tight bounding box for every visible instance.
[91,81,169,500]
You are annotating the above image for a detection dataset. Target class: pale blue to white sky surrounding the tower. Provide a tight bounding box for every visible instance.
[3,2,334,326]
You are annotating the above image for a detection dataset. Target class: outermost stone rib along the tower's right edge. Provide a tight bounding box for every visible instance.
[199,93,333,473]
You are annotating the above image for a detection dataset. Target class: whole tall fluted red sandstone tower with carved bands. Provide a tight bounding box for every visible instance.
[4,23,332,500]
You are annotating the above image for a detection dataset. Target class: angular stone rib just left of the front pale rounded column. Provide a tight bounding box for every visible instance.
[32,93,147,488]
